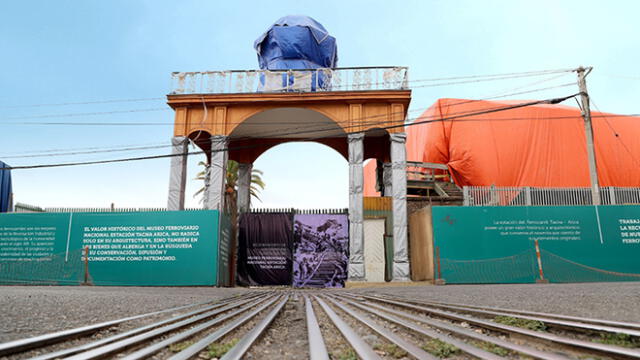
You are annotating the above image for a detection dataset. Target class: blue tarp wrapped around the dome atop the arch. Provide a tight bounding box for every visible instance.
[253,16,338,70]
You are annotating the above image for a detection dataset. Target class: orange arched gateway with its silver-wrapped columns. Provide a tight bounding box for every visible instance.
[168,90,410,280]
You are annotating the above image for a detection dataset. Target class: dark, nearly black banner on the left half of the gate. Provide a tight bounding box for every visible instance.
[238,213,293,286]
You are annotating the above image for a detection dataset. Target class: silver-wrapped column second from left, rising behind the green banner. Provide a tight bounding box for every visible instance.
[205,135,228,211]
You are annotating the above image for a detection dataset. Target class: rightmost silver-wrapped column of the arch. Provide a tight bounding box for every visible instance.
[391,133,409,281]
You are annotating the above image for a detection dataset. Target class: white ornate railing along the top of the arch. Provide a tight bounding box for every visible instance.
[171,66,409,95]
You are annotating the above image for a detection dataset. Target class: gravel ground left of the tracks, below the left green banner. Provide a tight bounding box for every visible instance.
[0,286,246,342]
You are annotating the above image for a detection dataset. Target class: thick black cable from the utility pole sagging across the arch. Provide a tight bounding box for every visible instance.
[0,94,579,170]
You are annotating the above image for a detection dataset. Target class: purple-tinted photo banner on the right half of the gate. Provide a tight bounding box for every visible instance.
[293,214,349,288]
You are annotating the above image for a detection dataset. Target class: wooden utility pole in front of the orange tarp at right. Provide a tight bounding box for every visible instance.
[576,66,601,205]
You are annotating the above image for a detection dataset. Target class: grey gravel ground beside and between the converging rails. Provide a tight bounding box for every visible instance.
[0,283,640,359]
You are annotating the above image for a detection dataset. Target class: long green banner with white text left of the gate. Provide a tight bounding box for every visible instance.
[0,211,219,286]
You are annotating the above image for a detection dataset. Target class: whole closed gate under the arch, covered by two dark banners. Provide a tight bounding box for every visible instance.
[238,209,349,288]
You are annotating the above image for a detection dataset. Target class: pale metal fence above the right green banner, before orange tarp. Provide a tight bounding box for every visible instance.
[463,186,640,206]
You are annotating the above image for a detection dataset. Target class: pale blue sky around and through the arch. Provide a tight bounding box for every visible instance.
[0,0,640,208]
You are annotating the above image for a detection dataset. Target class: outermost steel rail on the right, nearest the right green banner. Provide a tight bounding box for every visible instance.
[364,296,640,337]
